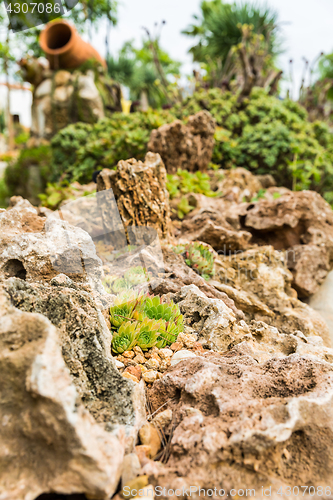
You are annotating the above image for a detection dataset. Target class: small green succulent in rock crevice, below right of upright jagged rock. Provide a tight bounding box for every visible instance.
[173,241,215,280]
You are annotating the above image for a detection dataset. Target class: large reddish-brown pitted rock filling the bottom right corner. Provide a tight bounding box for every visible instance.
[150,350,333,494]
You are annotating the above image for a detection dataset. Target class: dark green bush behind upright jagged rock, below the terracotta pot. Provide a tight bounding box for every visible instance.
[51,110,174,183]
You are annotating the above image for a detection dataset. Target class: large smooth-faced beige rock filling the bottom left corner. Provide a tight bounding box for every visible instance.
[0,291,125,500]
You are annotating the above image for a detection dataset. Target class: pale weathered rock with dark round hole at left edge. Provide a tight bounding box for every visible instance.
[0,197,101,282]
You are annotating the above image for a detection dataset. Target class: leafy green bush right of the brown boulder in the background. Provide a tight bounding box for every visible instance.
[173,88,333,199]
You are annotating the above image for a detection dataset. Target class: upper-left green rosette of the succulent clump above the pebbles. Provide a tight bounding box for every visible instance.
[110,293,144,328]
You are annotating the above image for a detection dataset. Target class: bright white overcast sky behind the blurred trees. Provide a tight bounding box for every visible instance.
[89,0,333,97]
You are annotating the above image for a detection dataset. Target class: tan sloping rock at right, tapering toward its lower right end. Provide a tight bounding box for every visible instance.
[211,246,331,346]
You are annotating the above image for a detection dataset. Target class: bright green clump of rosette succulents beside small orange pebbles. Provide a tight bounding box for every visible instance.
[110,292,184,354]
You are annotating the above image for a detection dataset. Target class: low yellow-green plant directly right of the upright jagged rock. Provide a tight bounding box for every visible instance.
[167,169,217,199]
